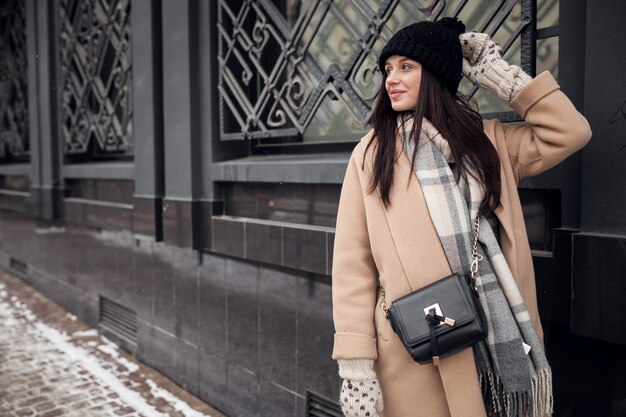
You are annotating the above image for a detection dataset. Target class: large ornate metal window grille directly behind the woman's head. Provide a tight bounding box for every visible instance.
[218,0,558,143]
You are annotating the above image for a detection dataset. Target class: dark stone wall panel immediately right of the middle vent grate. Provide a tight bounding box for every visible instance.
[137,321,177,377]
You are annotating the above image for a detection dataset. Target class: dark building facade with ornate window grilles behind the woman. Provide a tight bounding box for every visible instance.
[0,0,626,417]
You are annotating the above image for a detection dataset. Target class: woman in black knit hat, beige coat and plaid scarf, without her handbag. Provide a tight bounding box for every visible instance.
[332,18,591,417]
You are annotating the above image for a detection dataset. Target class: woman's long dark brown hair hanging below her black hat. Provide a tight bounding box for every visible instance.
[365,68,501,215]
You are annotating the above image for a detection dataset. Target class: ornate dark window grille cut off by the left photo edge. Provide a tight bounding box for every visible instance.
[0,0,29,162]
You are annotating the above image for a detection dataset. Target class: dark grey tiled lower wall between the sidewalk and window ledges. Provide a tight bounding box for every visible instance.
[0,211,339,417]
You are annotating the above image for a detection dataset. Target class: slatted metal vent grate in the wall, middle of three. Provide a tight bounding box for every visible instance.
[100,297,137,350]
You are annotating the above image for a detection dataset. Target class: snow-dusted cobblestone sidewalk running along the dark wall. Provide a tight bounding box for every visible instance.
[0,269,224,417]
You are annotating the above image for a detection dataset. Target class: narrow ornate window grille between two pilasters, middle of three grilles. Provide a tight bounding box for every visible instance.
[60,0,133,160]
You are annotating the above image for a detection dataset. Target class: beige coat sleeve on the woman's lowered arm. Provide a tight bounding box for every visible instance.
[332,145,378,359]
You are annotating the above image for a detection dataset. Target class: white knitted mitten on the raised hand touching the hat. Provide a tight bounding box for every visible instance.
[459,32,532,103]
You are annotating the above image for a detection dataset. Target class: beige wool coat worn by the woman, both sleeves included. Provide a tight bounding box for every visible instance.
[332,72,591,417]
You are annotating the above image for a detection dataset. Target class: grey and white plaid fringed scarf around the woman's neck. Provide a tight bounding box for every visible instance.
[398,116,553,417]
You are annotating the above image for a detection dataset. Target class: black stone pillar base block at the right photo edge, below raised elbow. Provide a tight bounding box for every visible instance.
[571,233,626,344]
